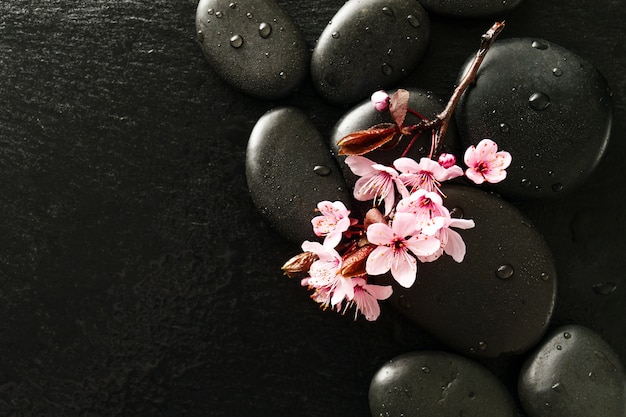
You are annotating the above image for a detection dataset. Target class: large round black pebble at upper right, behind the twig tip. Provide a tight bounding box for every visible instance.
[456,38,612,198]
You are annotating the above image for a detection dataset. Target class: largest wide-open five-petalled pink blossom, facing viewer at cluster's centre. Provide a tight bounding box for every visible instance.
[365,213,440,288]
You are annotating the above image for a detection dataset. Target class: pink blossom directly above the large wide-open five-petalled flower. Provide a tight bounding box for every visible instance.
[396,189,447,236]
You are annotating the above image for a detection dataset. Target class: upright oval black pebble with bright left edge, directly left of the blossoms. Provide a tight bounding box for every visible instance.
[246,107,351,244]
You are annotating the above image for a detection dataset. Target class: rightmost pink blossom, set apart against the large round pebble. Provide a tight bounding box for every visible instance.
[464,139,511,184]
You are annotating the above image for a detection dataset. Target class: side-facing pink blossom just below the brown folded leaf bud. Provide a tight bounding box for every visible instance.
[346,155,409,215]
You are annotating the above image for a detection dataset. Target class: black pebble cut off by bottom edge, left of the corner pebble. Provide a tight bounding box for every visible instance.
[369,351,517,417]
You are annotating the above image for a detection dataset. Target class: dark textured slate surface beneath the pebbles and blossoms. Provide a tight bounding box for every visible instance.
[0,0,626,416]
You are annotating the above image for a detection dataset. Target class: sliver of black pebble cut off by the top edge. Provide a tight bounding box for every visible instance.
[420,0,522,18]
